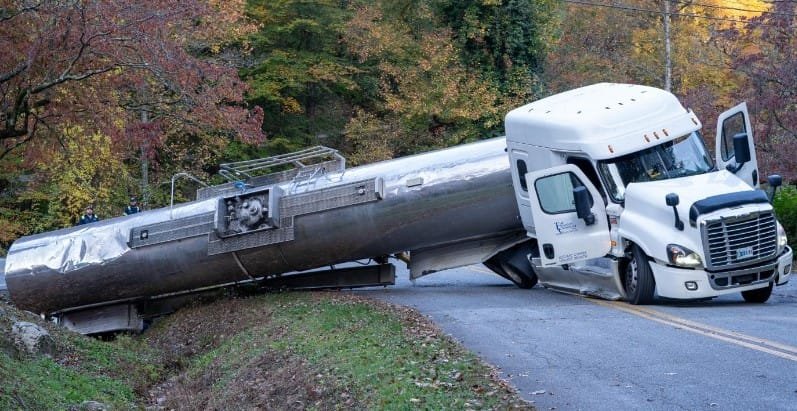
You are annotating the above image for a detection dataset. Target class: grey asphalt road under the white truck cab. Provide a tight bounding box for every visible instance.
[357,266,797,410]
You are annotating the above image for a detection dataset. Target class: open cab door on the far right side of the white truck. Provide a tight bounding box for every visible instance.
[716,103,758,188]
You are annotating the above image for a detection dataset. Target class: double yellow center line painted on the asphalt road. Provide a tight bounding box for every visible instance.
[588,299,797,362]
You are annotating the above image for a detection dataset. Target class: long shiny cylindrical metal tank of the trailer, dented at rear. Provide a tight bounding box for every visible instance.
[5,138,525,314]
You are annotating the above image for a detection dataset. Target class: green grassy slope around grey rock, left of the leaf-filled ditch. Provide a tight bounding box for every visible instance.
[0,303,162,410]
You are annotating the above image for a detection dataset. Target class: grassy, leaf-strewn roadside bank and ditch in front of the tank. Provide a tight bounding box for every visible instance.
[0,293,530,409]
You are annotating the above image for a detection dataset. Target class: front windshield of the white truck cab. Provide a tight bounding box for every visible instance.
[598,131,714,201]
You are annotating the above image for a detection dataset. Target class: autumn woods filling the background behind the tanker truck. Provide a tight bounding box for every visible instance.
[0,0,797,255]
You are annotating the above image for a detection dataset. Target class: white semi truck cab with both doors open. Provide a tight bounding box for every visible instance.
[506,83,792,304]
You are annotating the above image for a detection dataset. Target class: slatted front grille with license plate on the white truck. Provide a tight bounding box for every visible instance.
[703,211,778,268]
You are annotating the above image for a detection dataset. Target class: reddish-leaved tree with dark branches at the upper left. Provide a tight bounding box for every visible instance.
[0,0,264,245]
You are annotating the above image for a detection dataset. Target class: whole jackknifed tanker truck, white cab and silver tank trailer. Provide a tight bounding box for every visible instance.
[5,83,792,333]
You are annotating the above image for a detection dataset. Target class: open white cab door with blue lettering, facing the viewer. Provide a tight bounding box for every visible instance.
[526,164,611,266]
